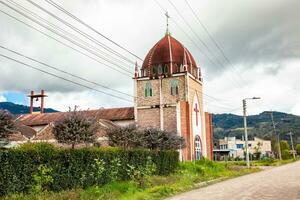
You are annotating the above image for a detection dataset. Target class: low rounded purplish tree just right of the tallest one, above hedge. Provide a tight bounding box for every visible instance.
[106,124,142,148]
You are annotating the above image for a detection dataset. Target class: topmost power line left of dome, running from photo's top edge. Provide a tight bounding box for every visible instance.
[45,0,143,61]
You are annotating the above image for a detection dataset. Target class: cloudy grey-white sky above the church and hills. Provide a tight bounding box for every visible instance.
[0,0,300,115]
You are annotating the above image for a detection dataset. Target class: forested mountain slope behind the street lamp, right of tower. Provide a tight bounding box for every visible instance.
[213,112,300,143]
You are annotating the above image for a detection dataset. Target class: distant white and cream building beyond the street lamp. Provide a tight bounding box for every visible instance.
[214,137,272,158]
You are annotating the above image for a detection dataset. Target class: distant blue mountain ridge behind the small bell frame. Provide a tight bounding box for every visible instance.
[0,102,57,115]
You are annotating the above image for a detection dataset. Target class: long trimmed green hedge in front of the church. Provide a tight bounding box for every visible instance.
[0,144,179,196]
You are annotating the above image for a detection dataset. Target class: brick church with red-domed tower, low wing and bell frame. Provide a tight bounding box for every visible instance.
[17,31,213,160]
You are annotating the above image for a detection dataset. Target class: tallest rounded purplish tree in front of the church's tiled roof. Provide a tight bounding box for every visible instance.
[53,108,98,148]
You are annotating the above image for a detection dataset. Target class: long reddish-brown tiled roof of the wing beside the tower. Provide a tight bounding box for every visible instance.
[18,107,134,126]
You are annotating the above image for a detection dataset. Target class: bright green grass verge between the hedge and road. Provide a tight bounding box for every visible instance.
[3,160,259,200]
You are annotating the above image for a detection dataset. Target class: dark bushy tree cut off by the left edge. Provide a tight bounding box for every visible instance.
[0,110,16,140]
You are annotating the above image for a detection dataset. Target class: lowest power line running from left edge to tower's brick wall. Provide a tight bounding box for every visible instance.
[0,54,131,103]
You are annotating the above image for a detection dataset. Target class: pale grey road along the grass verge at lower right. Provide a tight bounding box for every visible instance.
[169,161,300,200]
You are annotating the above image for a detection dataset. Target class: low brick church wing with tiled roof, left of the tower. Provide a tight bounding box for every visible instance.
[9,107,135,146]
